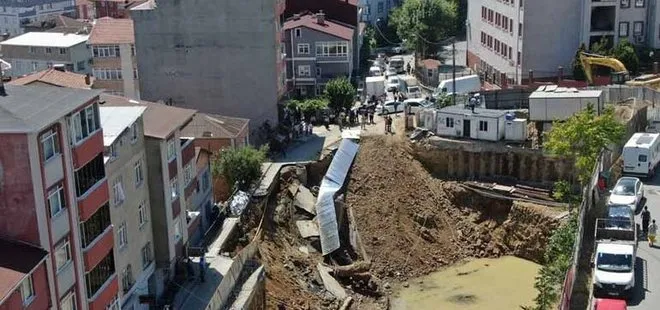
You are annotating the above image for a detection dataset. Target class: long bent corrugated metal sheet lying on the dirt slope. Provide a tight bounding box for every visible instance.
[316,139,359,255]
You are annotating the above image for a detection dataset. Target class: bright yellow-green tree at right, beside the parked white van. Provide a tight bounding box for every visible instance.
[543,104,624,184]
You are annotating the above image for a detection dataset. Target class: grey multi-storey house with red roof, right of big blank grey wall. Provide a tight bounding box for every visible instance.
[283,12,355,96]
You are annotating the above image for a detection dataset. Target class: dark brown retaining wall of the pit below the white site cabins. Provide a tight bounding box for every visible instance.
[414,137,574,186]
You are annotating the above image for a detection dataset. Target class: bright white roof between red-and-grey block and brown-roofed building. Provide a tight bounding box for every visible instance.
[99,106,147,146]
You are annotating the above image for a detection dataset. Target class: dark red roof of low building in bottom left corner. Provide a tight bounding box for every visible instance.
[0,239,48,300]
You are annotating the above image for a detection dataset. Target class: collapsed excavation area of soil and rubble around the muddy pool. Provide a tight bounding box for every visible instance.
[184,120,568,309]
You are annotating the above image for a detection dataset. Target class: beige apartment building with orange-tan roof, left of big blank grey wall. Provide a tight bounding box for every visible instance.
[88,17,140,99]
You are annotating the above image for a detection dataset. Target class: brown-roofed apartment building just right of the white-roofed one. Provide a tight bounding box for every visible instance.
[101,94,197,296]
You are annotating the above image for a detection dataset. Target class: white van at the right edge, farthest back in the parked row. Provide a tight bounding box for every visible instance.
[622,132,660,177]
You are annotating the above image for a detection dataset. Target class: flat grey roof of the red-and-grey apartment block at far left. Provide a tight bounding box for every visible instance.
[0,85,102,133]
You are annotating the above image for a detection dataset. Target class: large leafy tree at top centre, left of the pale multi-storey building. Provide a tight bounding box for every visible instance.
[389,0,459,57]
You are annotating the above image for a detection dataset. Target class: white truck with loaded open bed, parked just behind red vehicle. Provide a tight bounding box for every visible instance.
[591,218,637,298]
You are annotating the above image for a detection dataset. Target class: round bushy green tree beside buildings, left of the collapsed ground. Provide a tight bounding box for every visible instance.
[211,146,268,190]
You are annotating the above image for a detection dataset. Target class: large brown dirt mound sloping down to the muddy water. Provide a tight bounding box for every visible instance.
[346,136,556,280]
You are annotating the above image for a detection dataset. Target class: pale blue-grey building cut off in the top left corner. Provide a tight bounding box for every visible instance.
[0,0,76,36]
